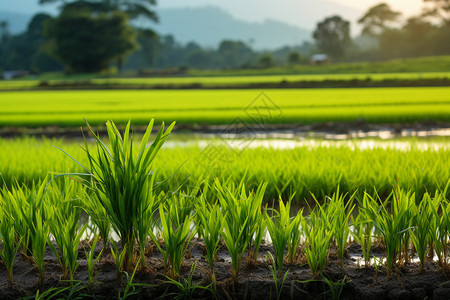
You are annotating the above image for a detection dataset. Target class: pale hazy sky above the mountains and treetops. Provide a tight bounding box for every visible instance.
[0,0,423,29]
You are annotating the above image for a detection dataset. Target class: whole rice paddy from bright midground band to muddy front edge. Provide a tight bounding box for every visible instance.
[0,81,450,299]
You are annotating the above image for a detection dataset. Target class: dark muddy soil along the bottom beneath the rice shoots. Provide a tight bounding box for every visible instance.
[0,239,450,299]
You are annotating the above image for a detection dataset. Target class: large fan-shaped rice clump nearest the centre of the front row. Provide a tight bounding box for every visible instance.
[215,180,267,282]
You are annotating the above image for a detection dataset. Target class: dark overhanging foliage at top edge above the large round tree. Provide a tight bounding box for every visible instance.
[39,0,158,21]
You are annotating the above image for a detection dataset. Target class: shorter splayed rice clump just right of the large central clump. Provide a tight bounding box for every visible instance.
[264,199,301,270]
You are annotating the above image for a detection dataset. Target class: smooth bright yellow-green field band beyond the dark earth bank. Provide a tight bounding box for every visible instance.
[0,87,450,126]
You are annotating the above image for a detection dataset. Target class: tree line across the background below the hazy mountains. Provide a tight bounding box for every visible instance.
[0,0,450,73]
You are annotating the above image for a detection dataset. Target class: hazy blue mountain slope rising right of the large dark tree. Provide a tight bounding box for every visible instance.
[146,6,311,49]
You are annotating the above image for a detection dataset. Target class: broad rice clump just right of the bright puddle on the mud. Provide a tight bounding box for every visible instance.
[368,194,412,279]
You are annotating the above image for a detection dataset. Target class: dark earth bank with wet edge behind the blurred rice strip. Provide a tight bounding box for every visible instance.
[0,119,450,139]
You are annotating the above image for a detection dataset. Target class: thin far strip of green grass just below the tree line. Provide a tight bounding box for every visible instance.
[0,72,450,90]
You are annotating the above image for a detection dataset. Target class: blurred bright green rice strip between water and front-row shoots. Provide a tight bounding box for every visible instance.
[0,137,450,200]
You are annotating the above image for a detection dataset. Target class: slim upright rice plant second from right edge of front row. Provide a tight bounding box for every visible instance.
[411,194,434,271]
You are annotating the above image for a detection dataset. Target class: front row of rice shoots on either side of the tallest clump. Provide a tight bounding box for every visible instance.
[0,177,450,283]
